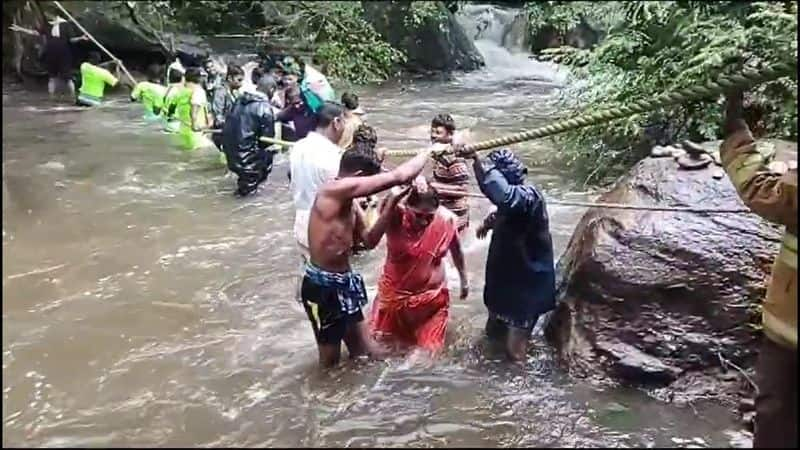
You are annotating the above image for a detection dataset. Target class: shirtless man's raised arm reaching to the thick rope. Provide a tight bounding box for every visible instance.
[322,150,431,200]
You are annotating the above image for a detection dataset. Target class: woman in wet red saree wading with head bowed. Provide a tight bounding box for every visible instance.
[370,182,468,353]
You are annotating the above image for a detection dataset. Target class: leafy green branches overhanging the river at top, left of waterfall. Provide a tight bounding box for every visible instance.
[128,0,441,83]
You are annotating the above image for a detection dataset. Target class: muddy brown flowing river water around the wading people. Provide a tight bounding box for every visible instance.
[2,6,736,447]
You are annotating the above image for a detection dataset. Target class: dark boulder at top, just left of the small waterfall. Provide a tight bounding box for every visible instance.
[361,1,485,72]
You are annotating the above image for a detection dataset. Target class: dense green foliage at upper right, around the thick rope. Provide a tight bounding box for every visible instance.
[526,1,797,181]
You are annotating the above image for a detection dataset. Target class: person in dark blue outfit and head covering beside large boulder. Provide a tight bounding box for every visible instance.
[462,149,555,361]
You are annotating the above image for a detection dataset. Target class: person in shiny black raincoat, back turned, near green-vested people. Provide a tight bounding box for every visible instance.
[222,75,277,196]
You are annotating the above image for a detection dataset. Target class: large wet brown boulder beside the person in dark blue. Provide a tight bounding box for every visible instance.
[546,142,797,398]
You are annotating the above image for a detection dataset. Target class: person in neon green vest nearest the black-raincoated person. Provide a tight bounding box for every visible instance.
[175,67,213,150]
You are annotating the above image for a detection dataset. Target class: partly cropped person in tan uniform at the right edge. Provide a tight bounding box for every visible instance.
[720,91,797,448]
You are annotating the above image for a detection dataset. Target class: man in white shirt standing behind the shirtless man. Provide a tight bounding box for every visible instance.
[289,102,345,258]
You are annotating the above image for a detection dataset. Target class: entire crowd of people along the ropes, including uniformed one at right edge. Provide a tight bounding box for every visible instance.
[31,14,797,446]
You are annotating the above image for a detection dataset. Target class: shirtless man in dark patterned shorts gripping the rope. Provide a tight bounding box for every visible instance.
[300,144,431,367]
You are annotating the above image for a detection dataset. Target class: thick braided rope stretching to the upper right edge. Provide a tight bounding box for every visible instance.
[386,64,796,156]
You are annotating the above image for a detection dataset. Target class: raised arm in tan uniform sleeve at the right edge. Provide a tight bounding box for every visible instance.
[720,92,797,227]
